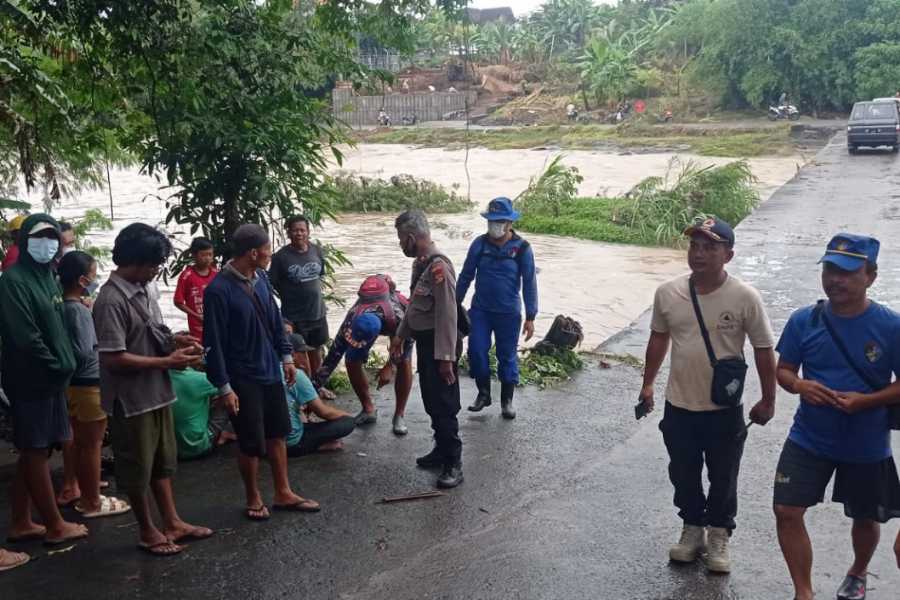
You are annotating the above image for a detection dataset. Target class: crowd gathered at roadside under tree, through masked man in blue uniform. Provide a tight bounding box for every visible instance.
[0,198,537,570]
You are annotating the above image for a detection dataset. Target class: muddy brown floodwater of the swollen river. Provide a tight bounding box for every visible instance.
[45,144,801,348]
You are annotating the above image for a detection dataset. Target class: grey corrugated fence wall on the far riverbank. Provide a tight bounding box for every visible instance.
[332,88,477,127]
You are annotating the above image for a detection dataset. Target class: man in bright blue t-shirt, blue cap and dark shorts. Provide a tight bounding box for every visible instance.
[775,233,900,600]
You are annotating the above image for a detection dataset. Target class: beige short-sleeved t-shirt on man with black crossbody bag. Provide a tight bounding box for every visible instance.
[650,275,775,411]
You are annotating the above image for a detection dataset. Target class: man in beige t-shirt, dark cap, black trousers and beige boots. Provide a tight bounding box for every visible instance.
[641,218,775,573]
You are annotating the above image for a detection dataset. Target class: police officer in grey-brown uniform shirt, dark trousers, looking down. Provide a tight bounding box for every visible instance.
[391,209,463,488]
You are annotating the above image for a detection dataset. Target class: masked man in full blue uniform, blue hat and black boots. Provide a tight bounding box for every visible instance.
[456,198,537,419]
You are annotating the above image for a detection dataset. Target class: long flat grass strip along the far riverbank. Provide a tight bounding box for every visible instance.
[355,125,795,158]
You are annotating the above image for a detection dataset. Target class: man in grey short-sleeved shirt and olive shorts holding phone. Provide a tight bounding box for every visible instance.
[94,223,213,556]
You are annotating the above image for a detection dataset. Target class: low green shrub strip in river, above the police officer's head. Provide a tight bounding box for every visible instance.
[326,174,475,214]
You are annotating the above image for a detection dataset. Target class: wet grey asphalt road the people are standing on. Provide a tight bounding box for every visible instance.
[0,136,900,600]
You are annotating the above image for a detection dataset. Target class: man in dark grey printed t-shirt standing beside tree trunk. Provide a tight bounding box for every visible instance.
[269,215,329,382]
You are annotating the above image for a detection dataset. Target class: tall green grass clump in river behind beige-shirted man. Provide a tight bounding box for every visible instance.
[517,158,759,246]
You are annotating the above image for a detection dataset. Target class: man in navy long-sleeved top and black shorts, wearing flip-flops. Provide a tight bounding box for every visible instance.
[203,224,319,521]
